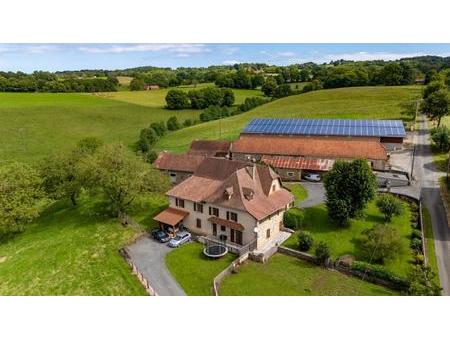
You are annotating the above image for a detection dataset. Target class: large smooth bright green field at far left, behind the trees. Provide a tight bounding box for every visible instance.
[0,93,199,162]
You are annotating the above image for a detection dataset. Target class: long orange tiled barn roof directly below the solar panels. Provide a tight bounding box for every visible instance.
[231,135,387,160]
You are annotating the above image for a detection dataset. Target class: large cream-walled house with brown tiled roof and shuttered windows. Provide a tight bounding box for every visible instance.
[154,158,294,249]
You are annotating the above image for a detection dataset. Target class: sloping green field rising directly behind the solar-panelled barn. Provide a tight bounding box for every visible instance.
[157,86,422,152]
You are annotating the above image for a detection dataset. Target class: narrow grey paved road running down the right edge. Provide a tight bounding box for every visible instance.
[413,116,450,295]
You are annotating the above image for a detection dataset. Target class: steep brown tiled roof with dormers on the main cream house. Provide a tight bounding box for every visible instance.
[167,158,294,220]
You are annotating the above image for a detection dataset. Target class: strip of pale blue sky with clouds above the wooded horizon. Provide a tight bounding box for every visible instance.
[0,43,450,72]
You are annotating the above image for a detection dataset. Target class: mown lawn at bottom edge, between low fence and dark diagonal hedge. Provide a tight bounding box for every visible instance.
[219,254,396,296]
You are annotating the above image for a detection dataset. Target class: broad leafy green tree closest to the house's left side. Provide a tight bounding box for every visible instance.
[84,144,170,216]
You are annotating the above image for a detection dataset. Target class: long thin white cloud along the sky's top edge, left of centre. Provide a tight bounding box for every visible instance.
[78,43,210,55]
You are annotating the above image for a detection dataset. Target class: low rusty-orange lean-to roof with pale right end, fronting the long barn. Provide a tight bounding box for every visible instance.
[261,155,334,171]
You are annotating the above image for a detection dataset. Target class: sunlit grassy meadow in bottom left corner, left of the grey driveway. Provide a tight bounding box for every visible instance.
[0,196,163,295]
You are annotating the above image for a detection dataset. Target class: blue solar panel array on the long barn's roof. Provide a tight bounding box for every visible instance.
[243,119,406,137]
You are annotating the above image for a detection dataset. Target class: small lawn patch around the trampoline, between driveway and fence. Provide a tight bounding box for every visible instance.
[166,242,236,296]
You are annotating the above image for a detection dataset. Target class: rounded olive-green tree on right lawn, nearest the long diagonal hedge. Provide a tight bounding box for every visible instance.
[358,224,404,263]
